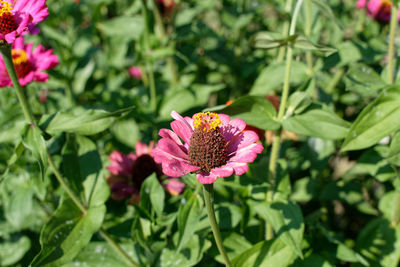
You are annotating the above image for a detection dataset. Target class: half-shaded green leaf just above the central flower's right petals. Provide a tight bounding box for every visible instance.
[213,96,279,130]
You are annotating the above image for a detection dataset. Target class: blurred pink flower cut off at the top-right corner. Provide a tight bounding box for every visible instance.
[356,0,400,22]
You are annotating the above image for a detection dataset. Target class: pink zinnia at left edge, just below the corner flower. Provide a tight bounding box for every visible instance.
[0,37,58,87]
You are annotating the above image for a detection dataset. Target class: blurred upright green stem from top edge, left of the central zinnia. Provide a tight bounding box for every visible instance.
[142,0,157,113]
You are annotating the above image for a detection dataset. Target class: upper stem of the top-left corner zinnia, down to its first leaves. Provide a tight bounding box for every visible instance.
[0,44,34,124]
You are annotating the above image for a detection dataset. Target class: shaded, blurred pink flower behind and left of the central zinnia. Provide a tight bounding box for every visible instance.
[107,142,185,203]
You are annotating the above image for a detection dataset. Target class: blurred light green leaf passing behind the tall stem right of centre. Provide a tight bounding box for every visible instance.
[250,61,309,95]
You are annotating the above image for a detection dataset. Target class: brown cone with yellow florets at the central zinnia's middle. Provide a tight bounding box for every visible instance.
[189,112,228,172]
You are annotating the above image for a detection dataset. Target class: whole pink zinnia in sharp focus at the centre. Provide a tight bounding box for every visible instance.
[152,111,263,184]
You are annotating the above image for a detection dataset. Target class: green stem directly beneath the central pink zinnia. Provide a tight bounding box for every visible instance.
[203,184,231,267]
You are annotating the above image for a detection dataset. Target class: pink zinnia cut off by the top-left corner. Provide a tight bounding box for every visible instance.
[0,0,49,44]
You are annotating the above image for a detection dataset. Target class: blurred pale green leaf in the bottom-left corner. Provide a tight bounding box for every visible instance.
[0,236,31,266]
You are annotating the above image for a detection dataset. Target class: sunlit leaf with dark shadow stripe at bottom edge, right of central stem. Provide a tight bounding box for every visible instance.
[232,239,295,267]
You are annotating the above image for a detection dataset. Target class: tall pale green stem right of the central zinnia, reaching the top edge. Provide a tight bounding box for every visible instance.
[265,0,303,240]
